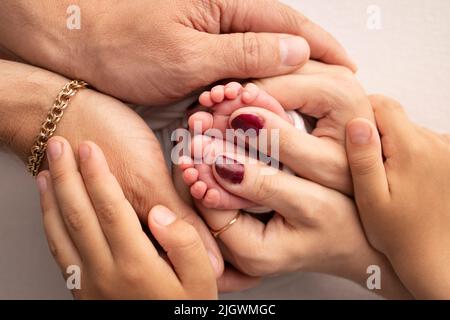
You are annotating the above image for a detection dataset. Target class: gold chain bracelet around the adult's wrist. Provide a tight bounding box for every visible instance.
[28,80,88,177]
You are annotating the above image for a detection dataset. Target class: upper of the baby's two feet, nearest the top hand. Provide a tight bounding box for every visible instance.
[189,82,292,134]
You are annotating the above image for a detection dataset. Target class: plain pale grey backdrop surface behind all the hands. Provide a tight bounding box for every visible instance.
[0,0,450,299]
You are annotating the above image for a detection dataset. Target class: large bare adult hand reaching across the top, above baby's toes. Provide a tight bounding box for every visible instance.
[0,0,355,105]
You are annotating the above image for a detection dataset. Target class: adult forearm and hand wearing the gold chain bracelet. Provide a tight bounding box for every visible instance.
[0,61,223,275]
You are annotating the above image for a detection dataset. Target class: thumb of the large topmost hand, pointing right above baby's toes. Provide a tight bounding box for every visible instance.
[206,32,310,80]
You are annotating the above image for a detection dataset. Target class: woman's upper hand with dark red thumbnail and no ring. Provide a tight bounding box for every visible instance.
[244,61,374,194]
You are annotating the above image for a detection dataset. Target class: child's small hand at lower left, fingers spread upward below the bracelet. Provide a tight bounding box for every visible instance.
[37,137,217,299]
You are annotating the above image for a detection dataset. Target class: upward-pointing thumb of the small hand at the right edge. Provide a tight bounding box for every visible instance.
[346,119,389,205]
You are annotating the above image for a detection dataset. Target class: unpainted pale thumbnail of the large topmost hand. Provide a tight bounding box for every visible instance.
[280,36,309,67]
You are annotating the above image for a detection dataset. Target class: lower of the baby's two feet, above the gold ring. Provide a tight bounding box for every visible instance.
[180,135,255,210]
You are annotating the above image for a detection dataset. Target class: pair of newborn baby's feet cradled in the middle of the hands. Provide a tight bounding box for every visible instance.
[180,82,292,209]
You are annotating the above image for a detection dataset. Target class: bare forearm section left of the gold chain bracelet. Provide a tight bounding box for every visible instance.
[0,60,68,160]
